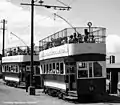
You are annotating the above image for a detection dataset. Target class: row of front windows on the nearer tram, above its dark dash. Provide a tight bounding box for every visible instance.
[77,61,103,79]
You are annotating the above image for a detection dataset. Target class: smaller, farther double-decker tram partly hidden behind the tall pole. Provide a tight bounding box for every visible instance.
[2,46,40,87]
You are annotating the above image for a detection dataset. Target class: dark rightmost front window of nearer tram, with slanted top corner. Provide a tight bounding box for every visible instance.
[93,62,102,77]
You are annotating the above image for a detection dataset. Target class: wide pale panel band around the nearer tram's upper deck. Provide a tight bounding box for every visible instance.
[39,43,106,60]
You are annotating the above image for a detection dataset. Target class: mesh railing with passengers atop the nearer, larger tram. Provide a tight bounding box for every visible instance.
[39,27,106,51]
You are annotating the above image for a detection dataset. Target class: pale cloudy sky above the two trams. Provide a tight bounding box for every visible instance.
[0,0,120,53]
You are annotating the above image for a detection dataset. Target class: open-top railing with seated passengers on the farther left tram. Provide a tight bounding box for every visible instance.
[5,46,39,56]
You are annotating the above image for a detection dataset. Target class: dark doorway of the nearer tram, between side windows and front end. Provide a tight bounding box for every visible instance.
[66,62,76,91]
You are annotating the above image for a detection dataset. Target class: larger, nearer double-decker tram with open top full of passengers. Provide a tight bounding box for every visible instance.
[39,23,106,98]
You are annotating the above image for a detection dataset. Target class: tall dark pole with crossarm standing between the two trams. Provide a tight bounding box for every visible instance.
[21,0,71,95]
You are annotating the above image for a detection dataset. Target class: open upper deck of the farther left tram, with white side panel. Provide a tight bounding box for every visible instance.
[2,46,39,63]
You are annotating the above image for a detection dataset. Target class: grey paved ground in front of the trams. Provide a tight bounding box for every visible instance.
[0,80,120,105]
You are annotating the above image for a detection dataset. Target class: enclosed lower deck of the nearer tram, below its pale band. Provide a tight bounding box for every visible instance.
[40,54,106,97]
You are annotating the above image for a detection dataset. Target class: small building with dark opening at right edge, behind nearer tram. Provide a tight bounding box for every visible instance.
[106,53,120,94]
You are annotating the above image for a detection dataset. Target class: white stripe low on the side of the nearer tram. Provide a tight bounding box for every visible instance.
[44,81,66,90]
